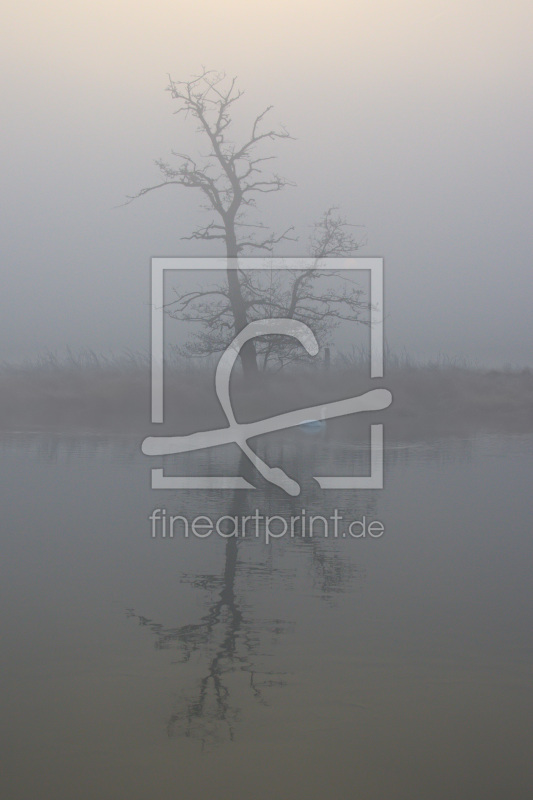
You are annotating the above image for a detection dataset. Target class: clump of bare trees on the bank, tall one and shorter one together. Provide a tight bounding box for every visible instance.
[128,70,367,377]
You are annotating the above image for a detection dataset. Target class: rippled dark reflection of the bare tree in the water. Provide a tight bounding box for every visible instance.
[128,444,370,747]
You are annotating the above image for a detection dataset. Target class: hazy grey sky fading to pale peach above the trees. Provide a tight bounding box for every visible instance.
[0,0,533,365]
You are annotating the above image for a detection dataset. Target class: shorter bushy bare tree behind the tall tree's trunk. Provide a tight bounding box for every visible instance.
[166,208,369,370]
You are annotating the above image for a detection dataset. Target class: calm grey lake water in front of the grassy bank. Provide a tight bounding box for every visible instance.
[0,431,533,800]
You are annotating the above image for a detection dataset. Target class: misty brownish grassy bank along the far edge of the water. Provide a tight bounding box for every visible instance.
[0,352,533,438]
